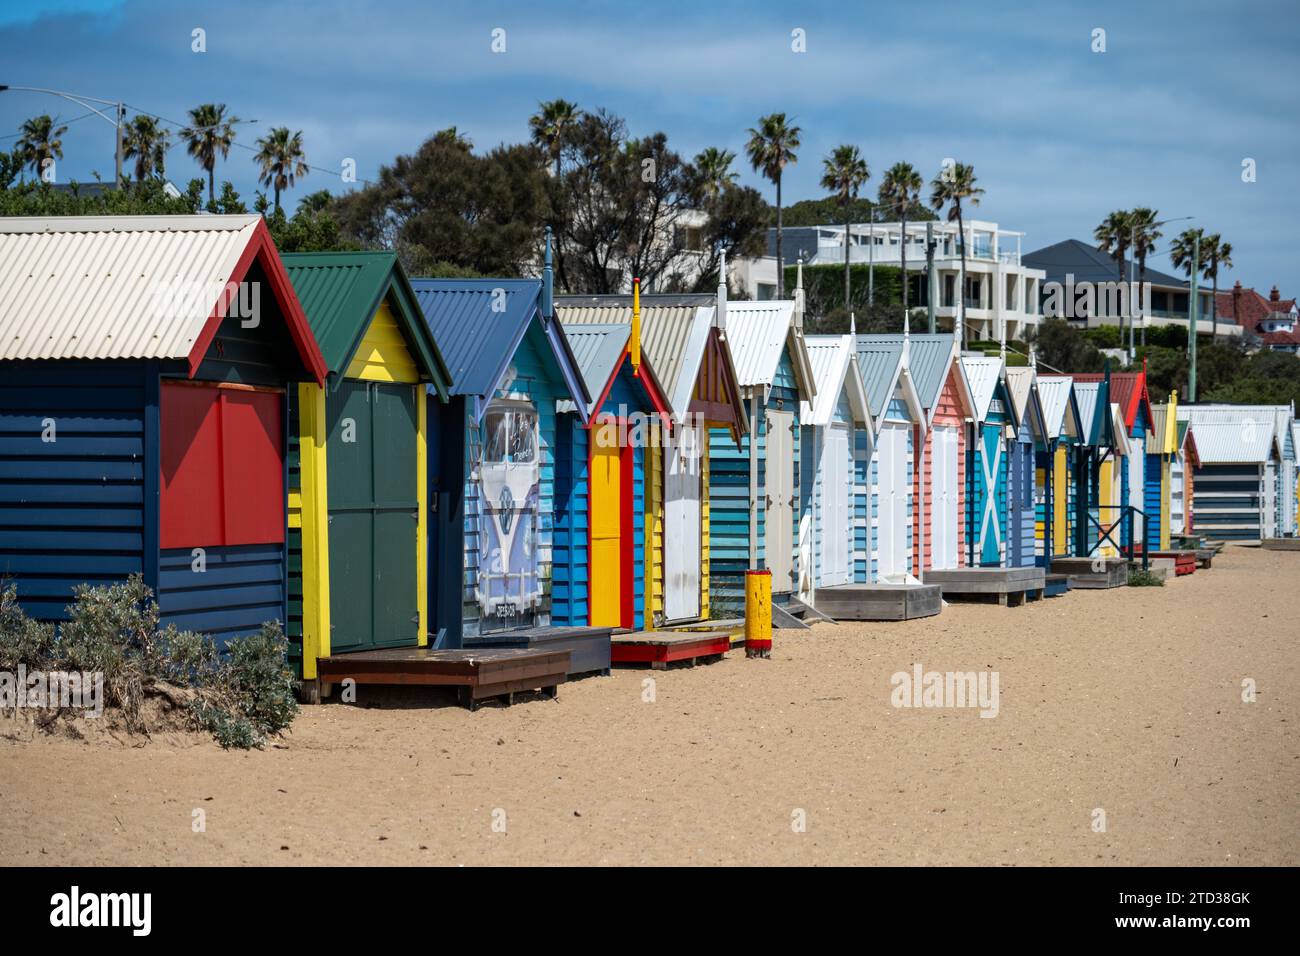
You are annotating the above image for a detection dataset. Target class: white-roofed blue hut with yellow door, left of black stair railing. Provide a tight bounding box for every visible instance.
[1034,375,1083,567]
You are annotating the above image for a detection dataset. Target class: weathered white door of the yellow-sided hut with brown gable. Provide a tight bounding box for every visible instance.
[663,425,702,620]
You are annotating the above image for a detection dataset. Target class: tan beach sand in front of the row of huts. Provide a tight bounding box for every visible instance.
[0,548,1300,866]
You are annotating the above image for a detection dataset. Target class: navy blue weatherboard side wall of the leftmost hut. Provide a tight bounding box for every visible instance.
[0,362,149,620]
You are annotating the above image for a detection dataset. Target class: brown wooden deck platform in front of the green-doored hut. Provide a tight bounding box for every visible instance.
[316,648,569,710]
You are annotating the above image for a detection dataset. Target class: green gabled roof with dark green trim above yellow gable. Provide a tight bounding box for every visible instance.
[281,252,451,398]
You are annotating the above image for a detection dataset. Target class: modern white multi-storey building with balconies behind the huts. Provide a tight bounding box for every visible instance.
[731,220,1047,339]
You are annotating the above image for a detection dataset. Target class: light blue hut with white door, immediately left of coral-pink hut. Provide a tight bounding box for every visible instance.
[854,336,926,584]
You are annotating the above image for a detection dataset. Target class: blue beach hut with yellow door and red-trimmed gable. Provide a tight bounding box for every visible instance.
[553,307,672,630]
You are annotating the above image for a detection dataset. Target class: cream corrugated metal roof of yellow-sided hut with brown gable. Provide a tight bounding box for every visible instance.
[555,295,715,421]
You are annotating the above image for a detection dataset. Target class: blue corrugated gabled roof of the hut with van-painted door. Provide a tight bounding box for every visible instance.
[411,278,592,420]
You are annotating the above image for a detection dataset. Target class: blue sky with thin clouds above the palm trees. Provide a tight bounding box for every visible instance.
[0,0,1300,291]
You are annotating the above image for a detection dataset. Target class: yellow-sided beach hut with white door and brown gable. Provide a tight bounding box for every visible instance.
[555,277,749,630]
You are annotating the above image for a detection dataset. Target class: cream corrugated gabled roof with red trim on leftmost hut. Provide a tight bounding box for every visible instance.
[0,216,325,382]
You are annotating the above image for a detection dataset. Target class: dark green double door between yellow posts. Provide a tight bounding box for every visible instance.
[325,380,419,652]
